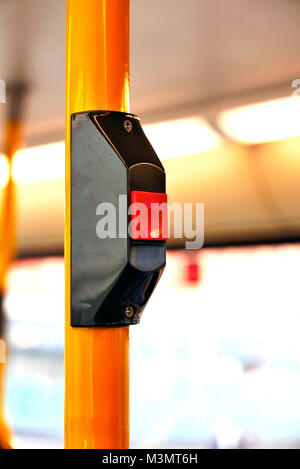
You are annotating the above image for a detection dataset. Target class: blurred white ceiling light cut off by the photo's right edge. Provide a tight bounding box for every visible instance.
[218,96,300,144]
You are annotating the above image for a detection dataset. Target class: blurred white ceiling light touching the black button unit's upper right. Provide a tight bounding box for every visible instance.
[144,117,220,160]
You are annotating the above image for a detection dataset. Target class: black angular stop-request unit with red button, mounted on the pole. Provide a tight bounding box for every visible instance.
[71,111,168,327]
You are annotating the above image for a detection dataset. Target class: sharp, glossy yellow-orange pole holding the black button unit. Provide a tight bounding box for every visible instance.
[65,0,129,449]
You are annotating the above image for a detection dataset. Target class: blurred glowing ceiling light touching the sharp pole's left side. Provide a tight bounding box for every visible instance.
[12,142,65,184]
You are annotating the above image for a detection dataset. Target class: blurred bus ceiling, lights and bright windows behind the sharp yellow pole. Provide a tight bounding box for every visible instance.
[0,0,300,448]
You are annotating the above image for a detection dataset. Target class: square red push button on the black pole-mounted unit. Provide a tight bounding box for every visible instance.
[130,191,168,240]
